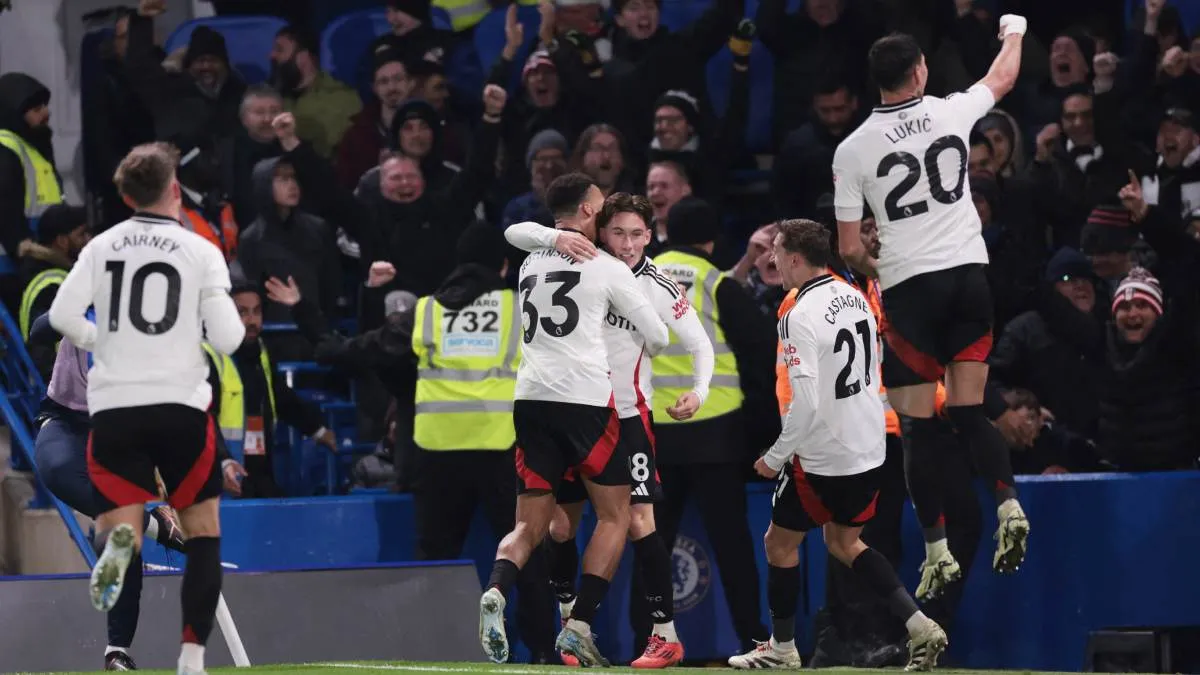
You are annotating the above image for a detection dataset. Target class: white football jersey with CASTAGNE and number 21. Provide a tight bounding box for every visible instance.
[768,275,887,476]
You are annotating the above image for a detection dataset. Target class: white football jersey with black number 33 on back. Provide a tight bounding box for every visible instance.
[515,243,668,406]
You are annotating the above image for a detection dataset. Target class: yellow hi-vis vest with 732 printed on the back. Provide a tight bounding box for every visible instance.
[413,291,521,450]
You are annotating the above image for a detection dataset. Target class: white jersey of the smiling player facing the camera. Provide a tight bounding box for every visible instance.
[604,257,714,419]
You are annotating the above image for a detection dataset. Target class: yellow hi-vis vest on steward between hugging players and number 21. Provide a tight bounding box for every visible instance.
[650,251,743,424]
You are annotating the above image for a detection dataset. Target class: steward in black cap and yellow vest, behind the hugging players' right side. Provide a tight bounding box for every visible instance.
[652,197,779,643]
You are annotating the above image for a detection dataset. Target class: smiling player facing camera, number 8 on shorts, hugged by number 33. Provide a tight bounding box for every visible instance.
[504,192,714,668]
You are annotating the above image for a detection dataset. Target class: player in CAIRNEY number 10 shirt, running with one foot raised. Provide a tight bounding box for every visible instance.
[50,143,245,674]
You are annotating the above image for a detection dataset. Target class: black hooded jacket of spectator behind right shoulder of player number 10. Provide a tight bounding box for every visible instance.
[238,157,342,323]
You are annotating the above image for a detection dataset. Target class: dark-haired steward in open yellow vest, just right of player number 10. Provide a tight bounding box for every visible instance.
[204,281,337,498]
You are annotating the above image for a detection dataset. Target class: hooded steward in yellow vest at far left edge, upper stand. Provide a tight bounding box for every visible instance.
[0,73,62,274]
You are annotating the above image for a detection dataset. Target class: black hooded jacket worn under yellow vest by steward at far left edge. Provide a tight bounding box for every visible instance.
[0,73,54,256]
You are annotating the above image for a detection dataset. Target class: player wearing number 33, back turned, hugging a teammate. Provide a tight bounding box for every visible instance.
[479,173,670,665]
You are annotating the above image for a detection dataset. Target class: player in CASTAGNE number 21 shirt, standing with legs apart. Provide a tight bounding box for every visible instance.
[730,220,947,670]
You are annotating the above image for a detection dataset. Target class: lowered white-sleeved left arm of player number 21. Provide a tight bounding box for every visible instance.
[762,312,820,473]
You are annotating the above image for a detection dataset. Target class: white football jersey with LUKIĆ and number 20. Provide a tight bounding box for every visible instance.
[833,84,996,289]
